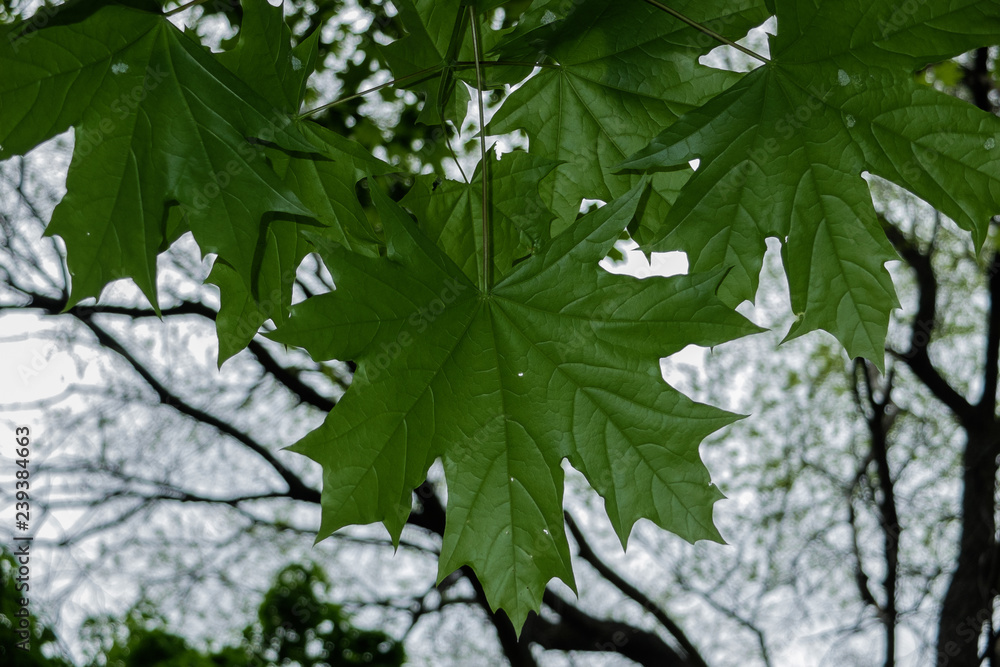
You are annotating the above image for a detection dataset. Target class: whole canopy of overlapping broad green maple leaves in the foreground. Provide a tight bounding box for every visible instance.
[0,0,1000,628]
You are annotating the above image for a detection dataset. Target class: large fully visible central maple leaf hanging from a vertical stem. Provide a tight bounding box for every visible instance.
[272,183,757,629]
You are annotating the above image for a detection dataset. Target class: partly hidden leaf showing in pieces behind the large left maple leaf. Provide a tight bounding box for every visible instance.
[209,0,389,366]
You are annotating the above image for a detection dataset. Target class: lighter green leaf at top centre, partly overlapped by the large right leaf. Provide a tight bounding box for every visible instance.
[488,0,767,234]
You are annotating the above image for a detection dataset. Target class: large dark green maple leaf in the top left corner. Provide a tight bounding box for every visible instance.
[0,0,312,305]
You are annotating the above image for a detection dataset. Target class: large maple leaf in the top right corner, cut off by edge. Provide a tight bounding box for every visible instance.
[623,0,1000,365]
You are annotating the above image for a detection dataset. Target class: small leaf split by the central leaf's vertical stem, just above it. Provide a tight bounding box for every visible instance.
[400,150,557,282]
